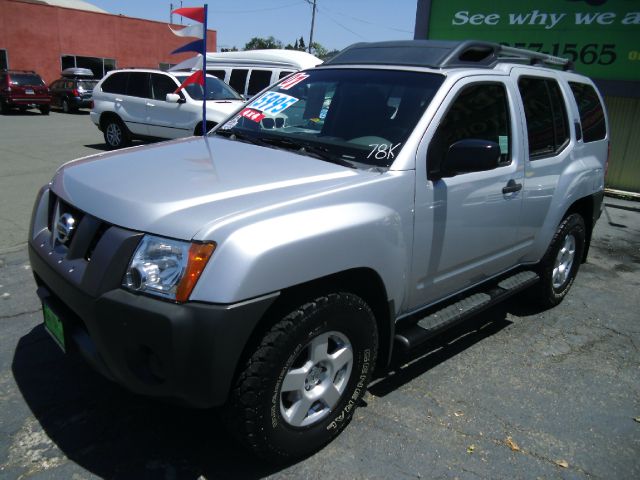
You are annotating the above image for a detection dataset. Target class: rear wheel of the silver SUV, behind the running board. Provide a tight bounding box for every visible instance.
[531,213,585,308]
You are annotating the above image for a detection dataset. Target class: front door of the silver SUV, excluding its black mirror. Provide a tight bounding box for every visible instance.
[410,77,524,308]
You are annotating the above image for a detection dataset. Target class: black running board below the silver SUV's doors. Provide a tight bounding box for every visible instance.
[395,271,539,350]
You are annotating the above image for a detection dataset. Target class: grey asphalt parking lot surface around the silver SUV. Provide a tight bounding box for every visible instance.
[0,112,640,480]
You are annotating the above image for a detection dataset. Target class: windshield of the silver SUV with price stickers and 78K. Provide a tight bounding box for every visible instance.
[215,69,444,168]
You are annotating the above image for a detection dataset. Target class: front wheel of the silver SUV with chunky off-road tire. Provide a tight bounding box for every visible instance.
[225,293,378,462]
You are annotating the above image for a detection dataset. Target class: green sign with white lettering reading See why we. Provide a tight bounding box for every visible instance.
[429,0,640,80]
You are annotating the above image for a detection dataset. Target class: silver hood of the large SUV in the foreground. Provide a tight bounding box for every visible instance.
[52,137,364,240]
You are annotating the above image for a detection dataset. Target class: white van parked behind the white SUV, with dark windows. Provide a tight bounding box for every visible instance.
[170,49,322,98]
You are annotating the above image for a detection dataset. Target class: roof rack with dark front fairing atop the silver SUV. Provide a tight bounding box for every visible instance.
[324,40,573,70]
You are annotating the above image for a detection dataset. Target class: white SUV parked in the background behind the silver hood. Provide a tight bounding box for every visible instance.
[91,69,243,149]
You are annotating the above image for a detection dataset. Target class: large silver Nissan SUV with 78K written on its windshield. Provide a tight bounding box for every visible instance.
[29,41,609,460]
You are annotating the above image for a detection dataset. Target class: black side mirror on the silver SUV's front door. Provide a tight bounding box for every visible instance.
[440,138,502,177]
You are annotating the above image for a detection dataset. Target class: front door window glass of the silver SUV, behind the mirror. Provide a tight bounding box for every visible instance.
[427,83,511,178]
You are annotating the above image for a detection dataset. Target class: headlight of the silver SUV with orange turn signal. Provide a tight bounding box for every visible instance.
[122,235,215,302]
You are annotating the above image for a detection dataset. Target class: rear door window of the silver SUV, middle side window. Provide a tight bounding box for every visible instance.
[518,77,569,160]
